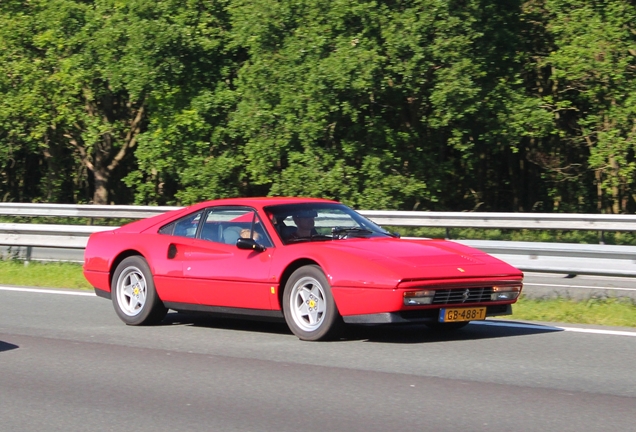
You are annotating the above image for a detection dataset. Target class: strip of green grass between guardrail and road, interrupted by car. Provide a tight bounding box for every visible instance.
[0,260,636,327]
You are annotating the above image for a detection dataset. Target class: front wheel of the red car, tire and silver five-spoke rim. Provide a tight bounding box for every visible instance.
[283,265,343,341]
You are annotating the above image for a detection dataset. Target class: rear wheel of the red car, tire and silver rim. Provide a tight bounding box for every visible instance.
[111,256,168,325]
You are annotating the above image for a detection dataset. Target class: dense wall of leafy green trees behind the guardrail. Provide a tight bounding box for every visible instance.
[0,0,636,213]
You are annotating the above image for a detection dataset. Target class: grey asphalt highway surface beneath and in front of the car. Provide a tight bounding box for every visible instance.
[0,282,636,432]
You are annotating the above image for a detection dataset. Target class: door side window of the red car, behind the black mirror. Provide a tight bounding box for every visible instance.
[201,207,273,247]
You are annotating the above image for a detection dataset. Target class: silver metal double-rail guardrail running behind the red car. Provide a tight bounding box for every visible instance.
[0,203,636,277]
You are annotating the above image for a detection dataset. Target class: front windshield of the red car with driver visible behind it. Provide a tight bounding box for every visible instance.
[265,203,390,244]
